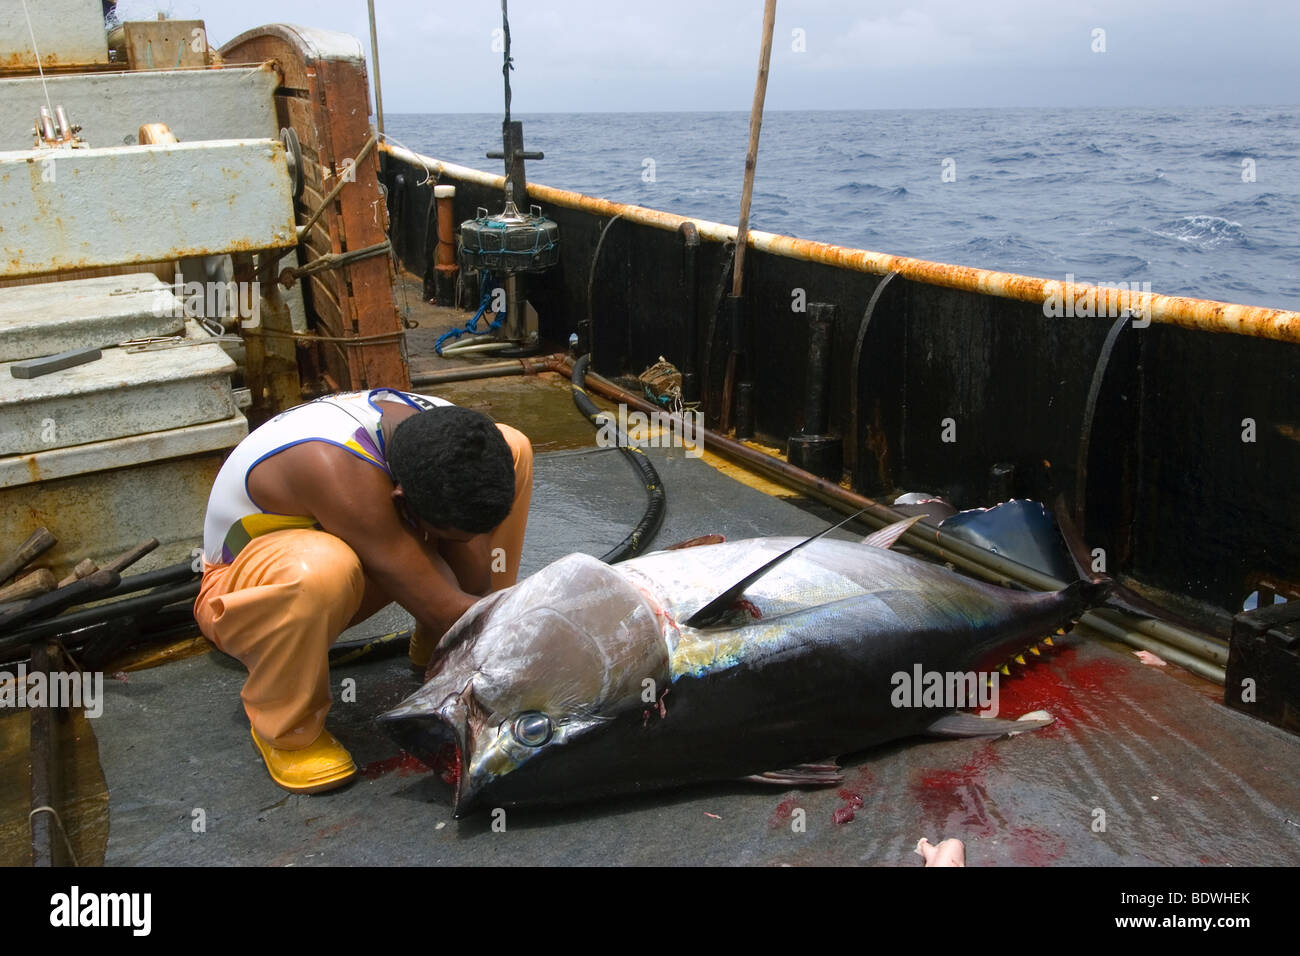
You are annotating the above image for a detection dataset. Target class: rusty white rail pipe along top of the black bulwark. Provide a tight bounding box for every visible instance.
[381,143,1300,343]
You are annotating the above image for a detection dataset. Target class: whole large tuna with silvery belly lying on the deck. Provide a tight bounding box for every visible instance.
[381,523,1104,816]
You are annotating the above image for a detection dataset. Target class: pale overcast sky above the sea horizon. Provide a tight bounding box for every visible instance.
[118,0,1300,113]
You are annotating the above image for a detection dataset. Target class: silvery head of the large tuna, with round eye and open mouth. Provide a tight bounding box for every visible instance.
[380,554,668,817]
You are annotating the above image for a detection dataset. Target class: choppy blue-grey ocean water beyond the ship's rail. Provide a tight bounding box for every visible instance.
[385,107,1300,310]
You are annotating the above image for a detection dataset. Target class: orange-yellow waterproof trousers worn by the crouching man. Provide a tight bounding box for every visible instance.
[194,425,533,750]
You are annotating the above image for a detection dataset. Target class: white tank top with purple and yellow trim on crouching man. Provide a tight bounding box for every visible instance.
[203,389,451,564]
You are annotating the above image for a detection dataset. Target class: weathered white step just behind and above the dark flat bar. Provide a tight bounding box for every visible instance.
[0,273,185,362]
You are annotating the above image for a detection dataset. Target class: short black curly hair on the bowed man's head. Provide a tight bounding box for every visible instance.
[387,405,515,535]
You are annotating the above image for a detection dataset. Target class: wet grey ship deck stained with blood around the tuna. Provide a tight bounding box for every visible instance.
[0,280,1300,866]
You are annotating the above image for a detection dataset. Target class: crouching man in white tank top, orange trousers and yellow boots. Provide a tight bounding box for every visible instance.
[194,389,533,793]
